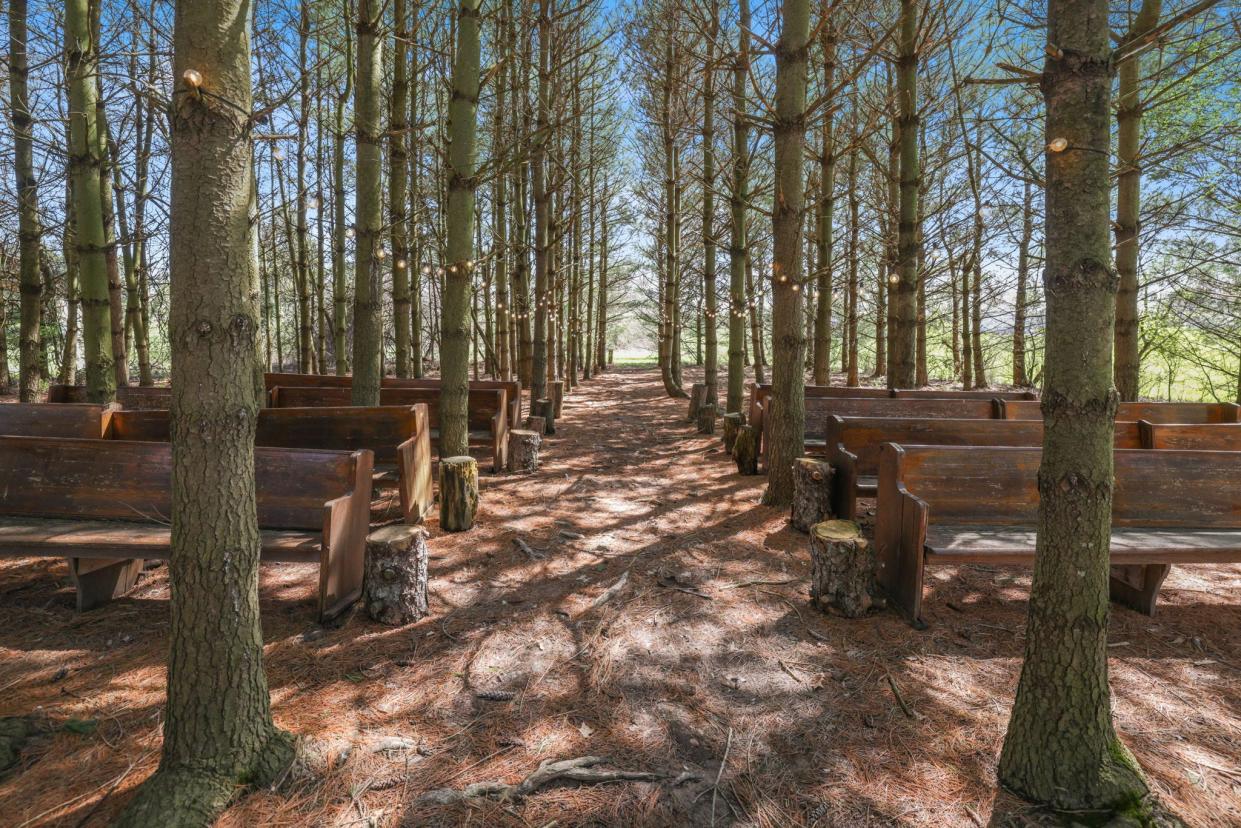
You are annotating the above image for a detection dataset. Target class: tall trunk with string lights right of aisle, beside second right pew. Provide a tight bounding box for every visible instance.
[763,0,810,506]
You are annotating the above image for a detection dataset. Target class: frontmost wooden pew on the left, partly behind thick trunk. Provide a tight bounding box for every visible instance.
[0,437,374,619]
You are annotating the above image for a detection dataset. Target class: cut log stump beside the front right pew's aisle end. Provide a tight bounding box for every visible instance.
[810,520,884,618]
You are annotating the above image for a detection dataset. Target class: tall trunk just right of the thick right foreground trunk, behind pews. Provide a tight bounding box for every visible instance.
[1116,0,1163,401]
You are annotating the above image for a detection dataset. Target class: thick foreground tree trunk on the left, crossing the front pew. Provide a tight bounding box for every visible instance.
[120,0,293,826]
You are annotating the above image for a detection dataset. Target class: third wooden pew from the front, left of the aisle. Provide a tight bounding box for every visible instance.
[272,386,510,473]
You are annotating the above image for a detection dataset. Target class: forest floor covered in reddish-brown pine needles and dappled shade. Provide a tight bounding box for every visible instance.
[0,370,1241,827]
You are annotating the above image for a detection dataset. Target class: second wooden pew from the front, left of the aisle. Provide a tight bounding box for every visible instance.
[105,403,434,524]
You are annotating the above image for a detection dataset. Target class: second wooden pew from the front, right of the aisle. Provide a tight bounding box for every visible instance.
[827,415,1143,520]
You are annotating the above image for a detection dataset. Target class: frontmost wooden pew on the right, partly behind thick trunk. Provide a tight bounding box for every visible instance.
[875,443,1241,626]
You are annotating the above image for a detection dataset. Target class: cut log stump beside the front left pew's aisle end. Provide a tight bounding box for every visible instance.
[362,525,431,627]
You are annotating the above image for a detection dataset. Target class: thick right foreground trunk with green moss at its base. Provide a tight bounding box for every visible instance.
[999,0,1147,811]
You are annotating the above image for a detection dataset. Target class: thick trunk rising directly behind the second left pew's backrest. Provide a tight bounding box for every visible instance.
[351,0,382,404]
